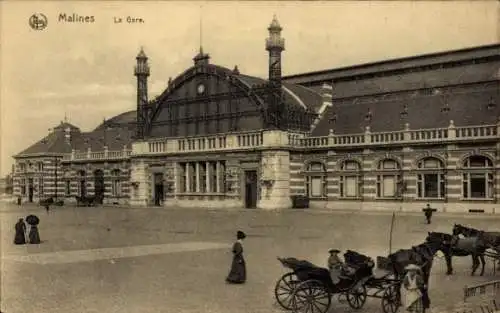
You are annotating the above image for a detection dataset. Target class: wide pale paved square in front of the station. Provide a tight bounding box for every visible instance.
[0,204,500,313]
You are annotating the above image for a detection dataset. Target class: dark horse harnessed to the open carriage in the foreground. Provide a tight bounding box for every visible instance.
[388,238,443,309]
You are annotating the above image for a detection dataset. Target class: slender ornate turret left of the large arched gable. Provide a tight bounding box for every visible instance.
[134,47,149,138]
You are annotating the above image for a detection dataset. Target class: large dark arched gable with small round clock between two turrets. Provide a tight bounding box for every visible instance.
[148,65,267,137]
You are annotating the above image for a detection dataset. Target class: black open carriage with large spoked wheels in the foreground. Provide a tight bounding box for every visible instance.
[274,250,401,313]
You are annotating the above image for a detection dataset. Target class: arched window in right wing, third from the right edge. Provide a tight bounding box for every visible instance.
[377,159,401,198]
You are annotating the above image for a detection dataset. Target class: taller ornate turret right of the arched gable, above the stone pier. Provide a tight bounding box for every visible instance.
[266,15,285,84]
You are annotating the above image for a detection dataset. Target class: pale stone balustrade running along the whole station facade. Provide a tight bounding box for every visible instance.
[52,122,500,161]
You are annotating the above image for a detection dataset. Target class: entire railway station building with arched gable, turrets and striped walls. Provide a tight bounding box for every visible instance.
[10,18,500,212]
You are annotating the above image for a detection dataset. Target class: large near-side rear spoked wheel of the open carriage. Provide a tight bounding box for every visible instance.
[291,280,332,313]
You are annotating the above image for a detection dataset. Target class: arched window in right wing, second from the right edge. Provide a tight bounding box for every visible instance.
[417,157,446,199]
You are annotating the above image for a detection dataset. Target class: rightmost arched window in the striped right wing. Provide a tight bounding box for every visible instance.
[462,155,494,199]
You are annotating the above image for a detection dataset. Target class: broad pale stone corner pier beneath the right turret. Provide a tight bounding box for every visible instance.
[257,131,292,210]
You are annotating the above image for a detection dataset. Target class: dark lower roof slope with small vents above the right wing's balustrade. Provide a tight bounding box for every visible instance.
[312,88,500,136]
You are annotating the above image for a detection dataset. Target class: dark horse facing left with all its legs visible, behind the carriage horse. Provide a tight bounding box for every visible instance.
[425,232,487,276]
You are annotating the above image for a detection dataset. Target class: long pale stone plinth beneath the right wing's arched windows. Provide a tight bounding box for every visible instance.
[309,200,500,214]
